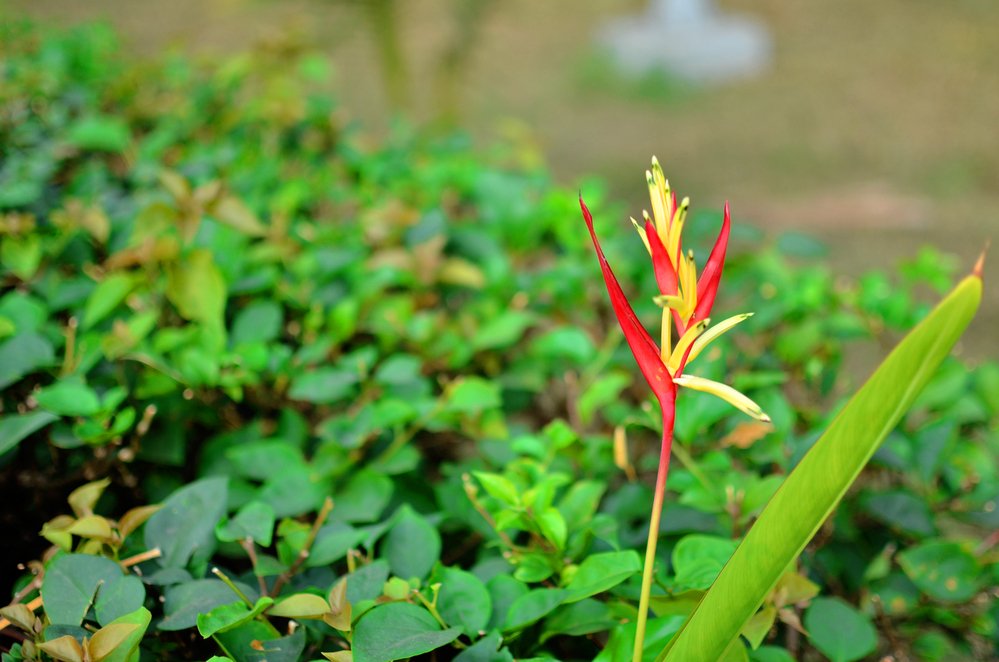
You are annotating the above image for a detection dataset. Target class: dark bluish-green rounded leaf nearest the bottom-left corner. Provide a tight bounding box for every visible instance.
[41,554,122,625]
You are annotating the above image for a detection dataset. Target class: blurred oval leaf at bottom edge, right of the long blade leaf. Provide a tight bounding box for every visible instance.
[805,598,878,662]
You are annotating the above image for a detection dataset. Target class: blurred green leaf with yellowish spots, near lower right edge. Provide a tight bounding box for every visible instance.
[898,540,982,602]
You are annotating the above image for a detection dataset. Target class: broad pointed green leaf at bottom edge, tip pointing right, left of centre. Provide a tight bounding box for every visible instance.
[352,602,461,662]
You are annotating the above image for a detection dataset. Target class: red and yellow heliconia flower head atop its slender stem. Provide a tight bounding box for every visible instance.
[579,158,770,426]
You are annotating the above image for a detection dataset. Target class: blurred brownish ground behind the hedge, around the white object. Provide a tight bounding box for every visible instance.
[7,0,999,355]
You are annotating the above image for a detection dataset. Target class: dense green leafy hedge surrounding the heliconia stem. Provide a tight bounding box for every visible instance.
[0,24,999,662]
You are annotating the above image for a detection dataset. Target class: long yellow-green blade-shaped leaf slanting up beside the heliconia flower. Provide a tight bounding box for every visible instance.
[659,276,982,661]
